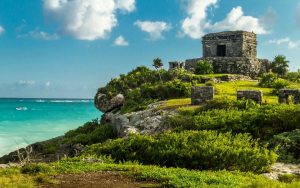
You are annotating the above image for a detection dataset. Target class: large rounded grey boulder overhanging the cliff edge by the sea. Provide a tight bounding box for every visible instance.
[95,93,125,113]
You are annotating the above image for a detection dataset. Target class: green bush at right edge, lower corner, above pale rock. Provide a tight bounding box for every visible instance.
[270,129,300,163]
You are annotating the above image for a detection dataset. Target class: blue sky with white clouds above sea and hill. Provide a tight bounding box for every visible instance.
[0,0,300,98]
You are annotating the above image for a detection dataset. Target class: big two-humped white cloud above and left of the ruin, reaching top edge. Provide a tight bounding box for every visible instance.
[181,0,267,39]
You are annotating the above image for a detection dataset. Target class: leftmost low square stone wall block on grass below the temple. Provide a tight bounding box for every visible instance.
[192,86,214,105]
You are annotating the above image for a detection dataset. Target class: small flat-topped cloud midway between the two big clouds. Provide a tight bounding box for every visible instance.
[134,20,172,40]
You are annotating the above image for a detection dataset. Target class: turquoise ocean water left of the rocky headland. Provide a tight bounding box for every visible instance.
[0,99,101,156]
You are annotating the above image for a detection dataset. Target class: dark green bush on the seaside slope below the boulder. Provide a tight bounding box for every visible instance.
[64,120,116,145]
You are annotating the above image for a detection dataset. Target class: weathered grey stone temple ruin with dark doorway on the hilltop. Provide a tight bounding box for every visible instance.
[169,31,269,77]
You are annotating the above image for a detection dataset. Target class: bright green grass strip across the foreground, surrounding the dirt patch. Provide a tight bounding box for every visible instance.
[0,158,300,188]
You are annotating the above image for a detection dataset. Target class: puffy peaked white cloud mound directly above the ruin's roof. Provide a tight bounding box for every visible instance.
[211,6,267,34]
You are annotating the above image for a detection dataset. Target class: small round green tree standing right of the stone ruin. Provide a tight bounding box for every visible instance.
[271,55,289,76]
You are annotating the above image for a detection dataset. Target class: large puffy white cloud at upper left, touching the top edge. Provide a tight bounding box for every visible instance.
[44,0,135,41]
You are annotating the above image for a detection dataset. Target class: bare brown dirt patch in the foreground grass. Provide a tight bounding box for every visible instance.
[44,171,160,188]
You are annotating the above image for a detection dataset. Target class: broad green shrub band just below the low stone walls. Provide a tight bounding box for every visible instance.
[166,101,300,140]
